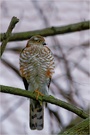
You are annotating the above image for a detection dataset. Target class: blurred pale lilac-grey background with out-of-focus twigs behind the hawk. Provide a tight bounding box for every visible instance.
[0,0,90,135]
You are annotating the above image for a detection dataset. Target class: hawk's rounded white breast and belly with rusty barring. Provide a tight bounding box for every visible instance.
[20,46,54,83]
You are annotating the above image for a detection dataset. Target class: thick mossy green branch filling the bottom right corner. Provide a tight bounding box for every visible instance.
[58,118,90,135]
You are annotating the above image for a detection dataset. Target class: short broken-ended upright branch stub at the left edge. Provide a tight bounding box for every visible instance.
[0,17,19,57]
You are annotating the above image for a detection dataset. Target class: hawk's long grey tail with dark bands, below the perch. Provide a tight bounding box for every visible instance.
[29,99,44,130]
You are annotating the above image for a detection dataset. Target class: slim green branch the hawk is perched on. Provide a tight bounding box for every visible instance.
[0,85,88,118]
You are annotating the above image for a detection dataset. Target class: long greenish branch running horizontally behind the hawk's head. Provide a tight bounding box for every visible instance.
[0,21,90,41]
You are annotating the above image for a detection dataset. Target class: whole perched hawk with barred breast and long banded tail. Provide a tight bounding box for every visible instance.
[19,35,55,130]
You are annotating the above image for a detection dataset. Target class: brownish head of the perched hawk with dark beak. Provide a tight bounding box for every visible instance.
[27,35,46,47]
